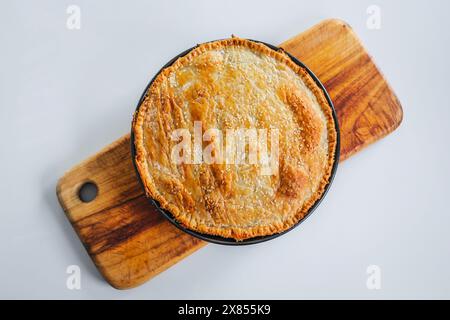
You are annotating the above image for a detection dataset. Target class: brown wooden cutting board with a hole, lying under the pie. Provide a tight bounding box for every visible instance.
[57,20,403,289]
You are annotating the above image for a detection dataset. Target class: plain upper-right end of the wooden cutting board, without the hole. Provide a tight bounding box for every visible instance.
[280,19,403,161]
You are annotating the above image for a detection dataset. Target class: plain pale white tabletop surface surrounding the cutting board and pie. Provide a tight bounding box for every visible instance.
[0,0,450,299]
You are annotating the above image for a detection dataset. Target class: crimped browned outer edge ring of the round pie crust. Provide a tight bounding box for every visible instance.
[132,37,337,240]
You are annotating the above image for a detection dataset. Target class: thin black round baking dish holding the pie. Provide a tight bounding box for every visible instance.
[131,39,340,245]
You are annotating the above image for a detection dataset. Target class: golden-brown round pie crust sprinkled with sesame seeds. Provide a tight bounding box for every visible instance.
[132,38,337,240]
